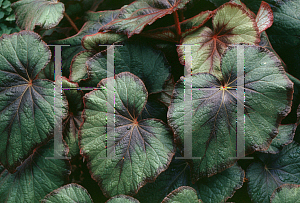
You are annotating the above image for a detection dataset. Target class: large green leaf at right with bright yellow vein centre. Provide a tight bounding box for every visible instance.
[168,45,293,182]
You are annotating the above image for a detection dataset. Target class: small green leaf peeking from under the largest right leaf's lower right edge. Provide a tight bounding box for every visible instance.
[261,124,297,154]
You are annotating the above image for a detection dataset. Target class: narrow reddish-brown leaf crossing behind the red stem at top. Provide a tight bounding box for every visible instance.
[141,11,213,42]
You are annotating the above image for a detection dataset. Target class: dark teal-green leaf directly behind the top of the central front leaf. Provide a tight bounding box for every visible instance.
[81,41,170,93]
